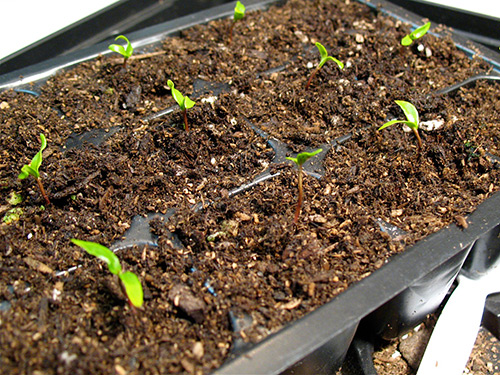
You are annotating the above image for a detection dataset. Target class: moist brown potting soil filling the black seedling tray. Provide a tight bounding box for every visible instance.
[0,0,500,374]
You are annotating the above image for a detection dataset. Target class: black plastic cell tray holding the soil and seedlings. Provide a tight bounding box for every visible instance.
[0,0,500,374]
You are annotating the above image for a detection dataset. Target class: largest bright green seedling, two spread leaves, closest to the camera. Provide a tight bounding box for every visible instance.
[71,238,144,307]
